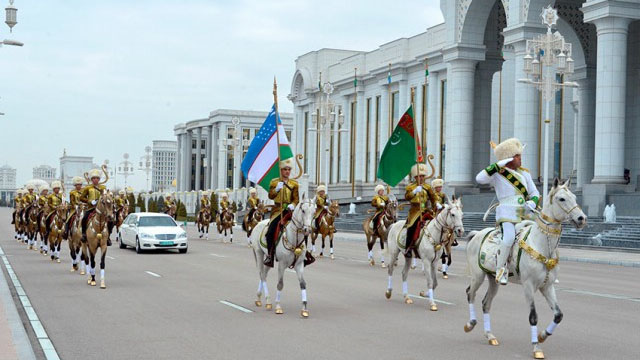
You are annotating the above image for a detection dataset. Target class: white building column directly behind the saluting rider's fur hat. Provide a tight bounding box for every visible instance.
[510,40,540,181]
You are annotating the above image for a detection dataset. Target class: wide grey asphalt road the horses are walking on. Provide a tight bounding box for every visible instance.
[0,208,640,359]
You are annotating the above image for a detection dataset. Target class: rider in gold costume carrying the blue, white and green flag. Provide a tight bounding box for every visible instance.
[264,158,299,267]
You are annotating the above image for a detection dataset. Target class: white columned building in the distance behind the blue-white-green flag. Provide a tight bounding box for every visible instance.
[174,109,295,192]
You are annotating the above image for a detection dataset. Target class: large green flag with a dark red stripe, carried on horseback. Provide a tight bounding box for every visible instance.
[378,105,418,186]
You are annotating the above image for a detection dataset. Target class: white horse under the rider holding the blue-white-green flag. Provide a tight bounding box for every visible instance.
[249,194,316,318]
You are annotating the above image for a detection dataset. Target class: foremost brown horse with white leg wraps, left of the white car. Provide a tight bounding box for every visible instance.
[87,190,113,289]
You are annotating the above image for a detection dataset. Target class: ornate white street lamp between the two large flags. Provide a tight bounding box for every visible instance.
[309,82,347,186]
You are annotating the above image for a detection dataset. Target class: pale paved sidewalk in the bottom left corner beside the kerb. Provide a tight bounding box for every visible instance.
[0,248,36,360]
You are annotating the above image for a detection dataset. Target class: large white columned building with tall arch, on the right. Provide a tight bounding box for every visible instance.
[289,0,640,215]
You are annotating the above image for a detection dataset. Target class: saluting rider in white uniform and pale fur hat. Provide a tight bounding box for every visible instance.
[476,138,540,285]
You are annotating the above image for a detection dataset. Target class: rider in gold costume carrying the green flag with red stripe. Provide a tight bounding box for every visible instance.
[404,164,436,256]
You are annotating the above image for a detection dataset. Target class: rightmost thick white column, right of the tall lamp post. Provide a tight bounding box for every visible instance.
[592,16,631,184]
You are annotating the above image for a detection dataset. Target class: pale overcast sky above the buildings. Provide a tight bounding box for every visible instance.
[0,0,443,189]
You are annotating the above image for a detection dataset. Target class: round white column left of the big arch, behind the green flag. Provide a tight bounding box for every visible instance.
[445,59,477,187]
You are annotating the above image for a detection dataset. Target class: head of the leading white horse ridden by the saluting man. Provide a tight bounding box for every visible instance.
[542,178,587,229]
